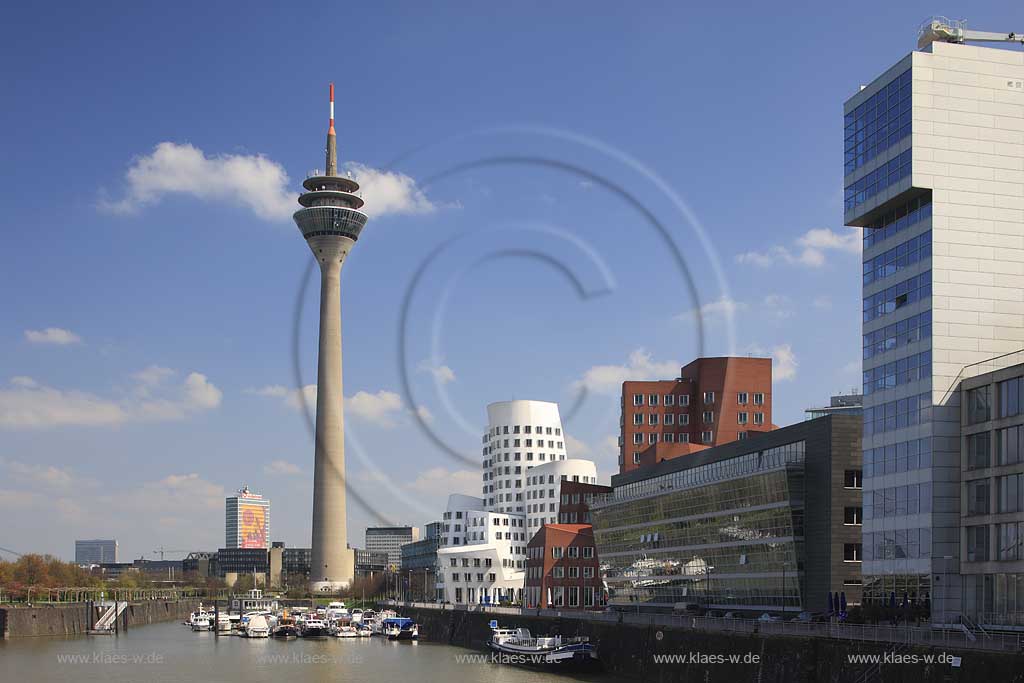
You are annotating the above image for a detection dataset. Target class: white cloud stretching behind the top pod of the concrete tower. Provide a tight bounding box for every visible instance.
[99,142,435,221]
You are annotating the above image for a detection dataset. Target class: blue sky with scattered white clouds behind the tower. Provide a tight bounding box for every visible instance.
[0,2,1024,557]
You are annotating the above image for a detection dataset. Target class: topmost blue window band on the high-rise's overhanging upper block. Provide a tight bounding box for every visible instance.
[843,69,911,175]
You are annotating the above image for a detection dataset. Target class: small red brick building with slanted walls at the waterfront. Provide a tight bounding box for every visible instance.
[523,524,607,609]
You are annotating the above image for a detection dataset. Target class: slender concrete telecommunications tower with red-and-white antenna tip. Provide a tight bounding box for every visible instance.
[293,83,368,592]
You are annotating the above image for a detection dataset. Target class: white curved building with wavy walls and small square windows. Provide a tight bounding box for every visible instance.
[437,400,597,604]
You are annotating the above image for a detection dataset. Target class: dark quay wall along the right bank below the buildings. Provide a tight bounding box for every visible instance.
[400,607,1024,683]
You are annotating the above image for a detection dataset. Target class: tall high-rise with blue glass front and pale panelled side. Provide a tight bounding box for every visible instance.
[844,19,1024,620]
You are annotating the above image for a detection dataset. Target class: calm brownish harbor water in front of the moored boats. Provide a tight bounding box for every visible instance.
[0,623,622,683]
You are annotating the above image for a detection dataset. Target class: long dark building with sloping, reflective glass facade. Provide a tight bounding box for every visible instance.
[591,415,860,612]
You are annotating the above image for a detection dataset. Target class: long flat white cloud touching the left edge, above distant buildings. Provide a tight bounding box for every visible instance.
[0,369,222,429]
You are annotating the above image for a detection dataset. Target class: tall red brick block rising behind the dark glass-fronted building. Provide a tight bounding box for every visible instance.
[618,356,775,473]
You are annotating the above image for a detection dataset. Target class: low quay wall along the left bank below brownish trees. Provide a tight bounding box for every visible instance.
[0,600,199,638]
